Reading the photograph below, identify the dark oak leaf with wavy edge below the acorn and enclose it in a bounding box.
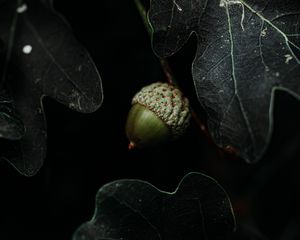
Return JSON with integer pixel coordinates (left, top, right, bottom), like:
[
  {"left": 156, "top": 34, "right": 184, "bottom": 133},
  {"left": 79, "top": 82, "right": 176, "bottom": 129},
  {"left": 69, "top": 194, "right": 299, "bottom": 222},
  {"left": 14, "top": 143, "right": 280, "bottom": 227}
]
[{"left": 73, "top": 173, "right": 235, "bottom": 240}]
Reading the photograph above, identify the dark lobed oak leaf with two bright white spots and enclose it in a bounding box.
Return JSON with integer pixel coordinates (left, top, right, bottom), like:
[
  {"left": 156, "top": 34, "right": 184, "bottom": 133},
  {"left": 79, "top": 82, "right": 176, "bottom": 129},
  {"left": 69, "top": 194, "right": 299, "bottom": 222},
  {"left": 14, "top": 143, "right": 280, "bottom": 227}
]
[{"left": 0, "top": 0, "right": 102, "bottom": 176}]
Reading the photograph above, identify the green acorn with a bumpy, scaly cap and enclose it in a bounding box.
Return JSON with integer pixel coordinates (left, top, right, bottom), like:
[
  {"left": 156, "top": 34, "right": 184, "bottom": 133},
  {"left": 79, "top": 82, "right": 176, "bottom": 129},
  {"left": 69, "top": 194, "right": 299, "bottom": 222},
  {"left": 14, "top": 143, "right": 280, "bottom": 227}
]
[{"left": 126, "top": 82, "right": 191, "bottom": 149}]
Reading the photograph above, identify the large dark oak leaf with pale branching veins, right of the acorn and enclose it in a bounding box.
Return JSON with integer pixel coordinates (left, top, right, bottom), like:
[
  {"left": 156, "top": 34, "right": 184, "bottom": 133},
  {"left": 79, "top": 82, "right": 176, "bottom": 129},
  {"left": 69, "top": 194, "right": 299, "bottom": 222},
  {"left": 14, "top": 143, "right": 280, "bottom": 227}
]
[{"left": 149, "top": 0, "right": 300, "bottom": 162}]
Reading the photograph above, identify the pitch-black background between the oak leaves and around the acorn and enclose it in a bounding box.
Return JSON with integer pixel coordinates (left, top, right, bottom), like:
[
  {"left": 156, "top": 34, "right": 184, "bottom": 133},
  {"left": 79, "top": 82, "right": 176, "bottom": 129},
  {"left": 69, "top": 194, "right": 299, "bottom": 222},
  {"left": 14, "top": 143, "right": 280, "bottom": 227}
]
[{"left": 0, "top": 0, "right": 300, "bottom": 240}]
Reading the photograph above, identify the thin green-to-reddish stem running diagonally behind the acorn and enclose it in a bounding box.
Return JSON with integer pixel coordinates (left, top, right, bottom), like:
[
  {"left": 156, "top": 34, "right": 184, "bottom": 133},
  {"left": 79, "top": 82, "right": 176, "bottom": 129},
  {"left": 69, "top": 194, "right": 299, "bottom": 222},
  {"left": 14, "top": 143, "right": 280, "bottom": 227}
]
[{"left": 134, "top": 0, "right": 213, "bottom": 143}]
